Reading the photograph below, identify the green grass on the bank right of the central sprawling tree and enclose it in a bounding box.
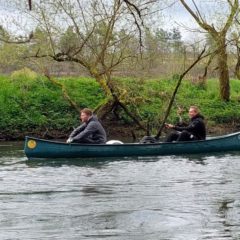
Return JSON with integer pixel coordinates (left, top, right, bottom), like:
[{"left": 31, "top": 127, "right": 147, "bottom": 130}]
[{"left": 111, "top": 76, "right": 240, "bottom": 131}]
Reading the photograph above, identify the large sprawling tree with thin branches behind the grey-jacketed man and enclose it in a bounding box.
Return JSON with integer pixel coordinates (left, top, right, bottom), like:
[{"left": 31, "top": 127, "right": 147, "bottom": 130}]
[{"left": 17, "top": 0, "right": 160, "bottom": 131}]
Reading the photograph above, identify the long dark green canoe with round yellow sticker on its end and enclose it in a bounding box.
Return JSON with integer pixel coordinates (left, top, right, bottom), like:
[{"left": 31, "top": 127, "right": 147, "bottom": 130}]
[{"left": 24, "top": 132, "right": 240, "bottom": 159}]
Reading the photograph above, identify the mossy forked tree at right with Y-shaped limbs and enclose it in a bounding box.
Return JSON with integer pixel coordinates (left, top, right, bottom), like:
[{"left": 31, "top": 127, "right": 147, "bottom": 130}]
[{"left": 180, "top": 0, "right": 239, "bottom": 101}]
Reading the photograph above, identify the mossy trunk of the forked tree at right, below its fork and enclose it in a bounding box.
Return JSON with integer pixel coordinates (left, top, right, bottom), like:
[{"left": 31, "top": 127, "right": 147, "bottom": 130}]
[{"left": 217, "top": 38, "right": 230, "bottom": 101}]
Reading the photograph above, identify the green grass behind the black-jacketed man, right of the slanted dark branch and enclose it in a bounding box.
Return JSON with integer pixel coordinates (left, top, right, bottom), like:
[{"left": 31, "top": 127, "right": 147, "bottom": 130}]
[{"left": 168, "top": 79, "right": 240, "bottom": 125}]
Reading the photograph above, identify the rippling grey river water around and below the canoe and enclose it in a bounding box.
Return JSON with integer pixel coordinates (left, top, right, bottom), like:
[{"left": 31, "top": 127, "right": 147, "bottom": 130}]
[{"left": 0, "top": 143, "right": 240, "bottom": 240}]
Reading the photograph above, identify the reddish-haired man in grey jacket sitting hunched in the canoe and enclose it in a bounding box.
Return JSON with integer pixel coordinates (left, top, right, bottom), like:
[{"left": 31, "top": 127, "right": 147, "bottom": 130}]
[{"left": 67, "top": 108, "right": 107, "bottom": 144}]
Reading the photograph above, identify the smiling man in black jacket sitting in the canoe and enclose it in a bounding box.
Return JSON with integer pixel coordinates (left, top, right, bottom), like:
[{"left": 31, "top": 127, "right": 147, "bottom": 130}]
[{"left": 166, "top": 106, "right": 206, "bottom": 142}]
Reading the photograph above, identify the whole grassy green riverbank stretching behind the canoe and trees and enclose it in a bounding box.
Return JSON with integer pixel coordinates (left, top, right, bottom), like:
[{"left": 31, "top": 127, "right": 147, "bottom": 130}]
[{"left": 0, "top": 72, "right": 240, "bottom": 139}]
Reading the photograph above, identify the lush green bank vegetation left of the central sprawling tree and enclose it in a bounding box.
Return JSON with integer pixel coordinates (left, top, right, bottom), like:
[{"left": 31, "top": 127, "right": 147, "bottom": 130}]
[{"left": 0, "top": 74, "right": 106, "bottom": 133}]
